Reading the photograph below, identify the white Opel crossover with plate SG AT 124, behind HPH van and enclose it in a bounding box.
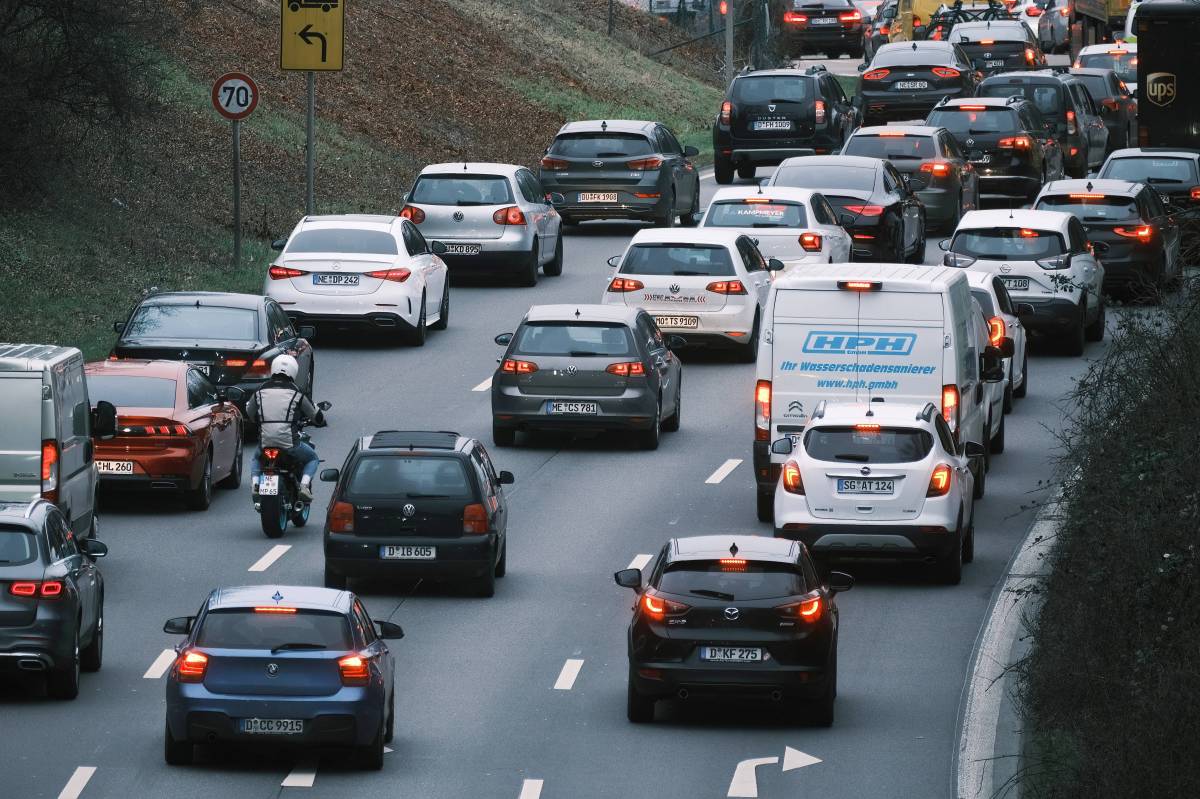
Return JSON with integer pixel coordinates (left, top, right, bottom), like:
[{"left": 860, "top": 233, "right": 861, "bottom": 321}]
[{"left": 772, "top": 402, "right": 980, "bottom": 584}]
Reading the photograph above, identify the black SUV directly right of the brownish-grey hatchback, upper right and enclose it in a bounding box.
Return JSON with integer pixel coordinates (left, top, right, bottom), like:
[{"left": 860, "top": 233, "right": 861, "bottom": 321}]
[{"left": 925, "top": 97, "right": 1062, "bottom": 200}]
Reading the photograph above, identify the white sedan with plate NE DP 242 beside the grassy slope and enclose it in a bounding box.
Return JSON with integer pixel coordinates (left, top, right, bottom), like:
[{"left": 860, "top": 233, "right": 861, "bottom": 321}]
[{"left": 263, "top": 214, "right": 450, "bottom": 347}]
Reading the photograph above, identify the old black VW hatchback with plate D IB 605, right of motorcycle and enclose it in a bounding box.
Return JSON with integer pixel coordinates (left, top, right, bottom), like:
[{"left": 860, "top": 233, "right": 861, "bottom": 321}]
[{"left": 320, "top": 431, "right": 514, "bottom": 596}]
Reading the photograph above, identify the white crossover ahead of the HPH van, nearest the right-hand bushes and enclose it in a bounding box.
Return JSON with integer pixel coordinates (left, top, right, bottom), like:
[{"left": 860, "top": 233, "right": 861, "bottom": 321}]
[{"left": 941, "top": 210, "right": 1104, "bottom": 355}]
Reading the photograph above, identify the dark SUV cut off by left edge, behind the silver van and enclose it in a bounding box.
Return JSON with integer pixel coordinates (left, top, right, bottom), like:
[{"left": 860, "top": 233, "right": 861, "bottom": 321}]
[{"left": 0, "top": 499, "right": 108, "bottom": 699}]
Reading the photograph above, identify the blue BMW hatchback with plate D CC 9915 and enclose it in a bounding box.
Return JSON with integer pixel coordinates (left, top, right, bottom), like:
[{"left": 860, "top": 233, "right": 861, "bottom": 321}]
[{"left": 163, "top": 585, "right": 404, "bottom": 769}]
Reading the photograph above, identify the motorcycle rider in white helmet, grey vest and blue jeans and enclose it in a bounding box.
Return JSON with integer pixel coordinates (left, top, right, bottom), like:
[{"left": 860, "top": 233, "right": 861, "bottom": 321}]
[{"left": 246, "top": 355, "right": 325, "bottom": 501}]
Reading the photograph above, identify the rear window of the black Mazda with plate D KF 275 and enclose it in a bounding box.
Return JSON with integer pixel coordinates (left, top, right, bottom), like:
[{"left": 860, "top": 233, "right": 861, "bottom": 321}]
[{"left": 656, "top": 558, "right": 808, "bottom": 602}]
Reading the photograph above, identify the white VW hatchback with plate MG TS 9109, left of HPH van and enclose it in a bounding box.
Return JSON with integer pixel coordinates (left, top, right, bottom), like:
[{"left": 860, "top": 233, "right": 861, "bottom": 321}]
[{"left": 600, "top": 228, "right": 784, "bottom": 361}]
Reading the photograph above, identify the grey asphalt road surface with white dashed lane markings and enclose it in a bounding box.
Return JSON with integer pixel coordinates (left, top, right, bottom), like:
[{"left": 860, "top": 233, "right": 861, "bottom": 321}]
[{"left": 0, "top": 169, "right": 1102, "bottom": 799}]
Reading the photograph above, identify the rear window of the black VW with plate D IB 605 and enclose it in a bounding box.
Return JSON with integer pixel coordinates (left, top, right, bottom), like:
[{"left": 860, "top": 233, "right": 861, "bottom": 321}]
[{"left": 346, "top": 455, "right": 475, "bottom": 499}]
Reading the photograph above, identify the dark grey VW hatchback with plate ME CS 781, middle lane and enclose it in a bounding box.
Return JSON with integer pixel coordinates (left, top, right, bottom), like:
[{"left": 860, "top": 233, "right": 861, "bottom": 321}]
[{"left": 492, "top": 305, "right": 683, "bottom": 450}]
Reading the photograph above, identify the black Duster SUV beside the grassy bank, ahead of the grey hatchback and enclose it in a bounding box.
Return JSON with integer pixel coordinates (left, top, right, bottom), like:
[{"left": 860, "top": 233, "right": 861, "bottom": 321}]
[{"left": 713, "top": 66, "right": 858, "bottom": 184}]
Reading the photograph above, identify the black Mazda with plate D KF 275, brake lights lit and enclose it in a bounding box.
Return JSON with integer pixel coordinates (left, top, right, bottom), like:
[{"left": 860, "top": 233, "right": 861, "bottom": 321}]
[{"left": 614, "top": 535, "right": 854, "bottom": 726}]
